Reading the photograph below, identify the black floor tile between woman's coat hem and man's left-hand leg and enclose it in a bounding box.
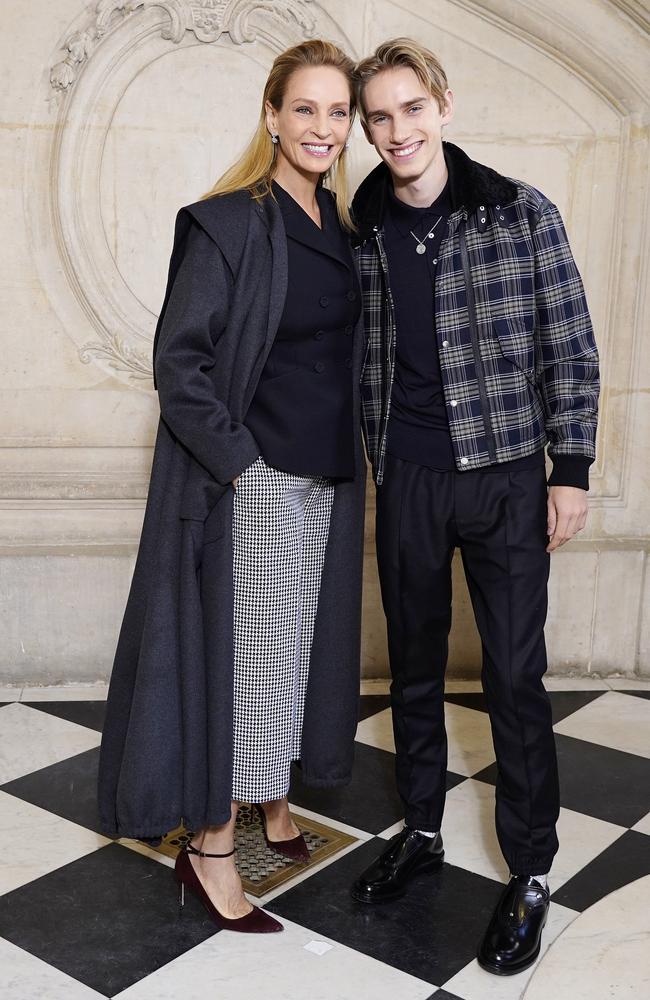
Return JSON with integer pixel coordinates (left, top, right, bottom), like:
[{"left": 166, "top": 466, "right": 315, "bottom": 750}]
[{"left": 289, "top": 743, "right": 465, "bottom": 833}]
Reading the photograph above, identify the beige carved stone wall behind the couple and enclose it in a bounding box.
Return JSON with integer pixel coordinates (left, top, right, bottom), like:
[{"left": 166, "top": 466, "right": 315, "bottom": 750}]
[{"left": 0, "top": 0, "right": 650, "bottom": 684}]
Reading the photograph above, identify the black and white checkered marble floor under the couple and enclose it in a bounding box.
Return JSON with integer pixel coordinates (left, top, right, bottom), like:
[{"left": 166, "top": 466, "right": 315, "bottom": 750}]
[{"left": 0, "top": 680, "right": 650, "bottom": 1000}]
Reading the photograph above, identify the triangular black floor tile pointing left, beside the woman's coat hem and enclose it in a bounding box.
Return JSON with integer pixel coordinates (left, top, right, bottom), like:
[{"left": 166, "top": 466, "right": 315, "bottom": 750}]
[{"left": 2, "top": 747, "right": 103, "bottom": 833}]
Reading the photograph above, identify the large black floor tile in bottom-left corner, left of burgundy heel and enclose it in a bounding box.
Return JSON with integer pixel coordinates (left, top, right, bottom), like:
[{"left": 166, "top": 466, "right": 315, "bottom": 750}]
[{"left": 0, "top": 844, "right": 215, "bottom": 997}]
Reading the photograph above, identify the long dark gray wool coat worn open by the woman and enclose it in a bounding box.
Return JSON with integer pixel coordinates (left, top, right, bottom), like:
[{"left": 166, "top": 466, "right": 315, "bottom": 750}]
[{"left": 98, "top": 186, "right": 365, "bottom": 839}]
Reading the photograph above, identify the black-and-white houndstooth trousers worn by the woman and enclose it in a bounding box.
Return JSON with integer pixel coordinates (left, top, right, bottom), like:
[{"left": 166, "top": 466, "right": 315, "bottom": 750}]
[{"left": 232, "top": 457, "right": 334, "bottom": 802}]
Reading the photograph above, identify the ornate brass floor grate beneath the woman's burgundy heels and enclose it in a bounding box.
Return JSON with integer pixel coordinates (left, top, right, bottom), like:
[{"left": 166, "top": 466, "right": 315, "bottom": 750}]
[{"left": 146, "top": 803, "right": 356, "bottom": 897}]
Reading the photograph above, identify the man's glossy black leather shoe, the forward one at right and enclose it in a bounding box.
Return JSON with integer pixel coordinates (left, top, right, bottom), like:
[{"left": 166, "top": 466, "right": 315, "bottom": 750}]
[{"left": 477, "top": 875, "right": 550, "bottom": 976}]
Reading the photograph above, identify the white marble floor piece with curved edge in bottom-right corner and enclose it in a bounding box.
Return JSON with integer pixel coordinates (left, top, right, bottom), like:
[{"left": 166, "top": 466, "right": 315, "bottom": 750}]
[{"left": 524, "top": 875, "right": 650, "bottom": 1000}]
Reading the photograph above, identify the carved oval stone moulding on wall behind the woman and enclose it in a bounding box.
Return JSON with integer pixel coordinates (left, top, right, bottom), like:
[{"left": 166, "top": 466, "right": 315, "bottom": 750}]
[{"left": 27, "top": 0, "right": 352, "bottom": 388}]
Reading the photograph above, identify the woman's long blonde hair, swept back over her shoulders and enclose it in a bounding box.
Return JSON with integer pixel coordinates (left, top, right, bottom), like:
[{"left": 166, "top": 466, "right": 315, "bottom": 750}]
[{"left": 203, "top": 38, "right": 356, "bottom": 230}]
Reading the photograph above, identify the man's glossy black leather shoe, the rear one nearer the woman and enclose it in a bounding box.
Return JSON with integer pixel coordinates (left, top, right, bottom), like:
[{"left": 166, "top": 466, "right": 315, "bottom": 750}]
[{"left": 351, "top": 828, "right": 445, "bottom": 903}]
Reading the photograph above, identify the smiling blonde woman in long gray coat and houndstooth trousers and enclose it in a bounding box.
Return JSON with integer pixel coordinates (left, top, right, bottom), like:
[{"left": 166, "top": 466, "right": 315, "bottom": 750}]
[{"left": 99, "top": 41, "right": 365, "bottom": 932}]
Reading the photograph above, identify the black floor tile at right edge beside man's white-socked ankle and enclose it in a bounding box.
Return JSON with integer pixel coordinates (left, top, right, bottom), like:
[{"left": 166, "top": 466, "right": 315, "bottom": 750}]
[{"left": 550, "top": 830, "right": 650, "bottom": 910}]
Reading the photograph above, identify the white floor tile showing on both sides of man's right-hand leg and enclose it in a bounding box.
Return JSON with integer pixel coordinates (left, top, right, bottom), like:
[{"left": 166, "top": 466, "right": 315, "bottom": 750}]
[{"left": 442, "top": 780, "right": 625, "bottom": 892}]
